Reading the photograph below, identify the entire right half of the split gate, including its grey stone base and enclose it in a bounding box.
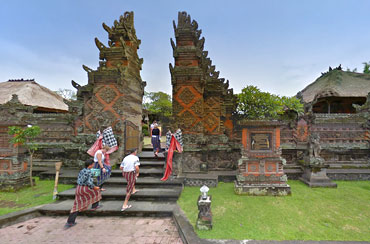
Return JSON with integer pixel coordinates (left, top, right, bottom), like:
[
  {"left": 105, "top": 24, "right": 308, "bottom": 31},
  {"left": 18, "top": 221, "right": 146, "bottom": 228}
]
[{"left": 170, "top": 12, "right": 237, "bottom": 174}]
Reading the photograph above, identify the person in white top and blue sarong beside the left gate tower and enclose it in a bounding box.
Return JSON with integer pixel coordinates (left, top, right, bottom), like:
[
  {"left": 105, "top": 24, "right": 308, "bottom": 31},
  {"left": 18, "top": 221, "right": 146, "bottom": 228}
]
[{"left": 94, "top": 146, "right": 112, "bottom": 191}]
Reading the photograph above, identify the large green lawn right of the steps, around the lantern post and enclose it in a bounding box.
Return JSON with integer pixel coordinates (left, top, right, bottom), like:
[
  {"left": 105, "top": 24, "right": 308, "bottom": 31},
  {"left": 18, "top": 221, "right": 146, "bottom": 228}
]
[{"left": 178, "top": 181, "right": 370, "bottom": 241}]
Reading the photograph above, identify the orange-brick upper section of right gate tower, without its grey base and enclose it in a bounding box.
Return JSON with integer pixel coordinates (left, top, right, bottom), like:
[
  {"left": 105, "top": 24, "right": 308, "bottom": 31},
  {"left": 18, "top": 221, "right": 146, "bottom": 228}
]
[{"left": 170, "top": 12, "right": 234, "bottom": 135}]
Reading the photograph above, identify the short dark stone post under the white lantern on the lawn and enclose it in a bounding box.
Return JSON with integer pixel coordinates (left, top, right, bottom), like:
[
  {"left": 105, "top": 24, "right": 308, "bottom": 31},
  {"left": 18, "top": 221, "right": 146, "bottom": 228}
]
[{"left": 196, "top": 196, "right": 212, "bottom": 230}]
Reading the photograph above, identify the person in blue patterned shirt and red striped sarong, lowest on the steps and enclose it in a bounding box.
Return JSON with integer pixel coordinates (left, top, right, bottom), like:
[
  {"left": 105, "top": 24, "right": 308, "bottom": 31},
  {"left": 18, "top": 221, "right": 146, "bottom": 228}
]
[{"left": 64, "top": 159, "right": 102, "bottom": 229}]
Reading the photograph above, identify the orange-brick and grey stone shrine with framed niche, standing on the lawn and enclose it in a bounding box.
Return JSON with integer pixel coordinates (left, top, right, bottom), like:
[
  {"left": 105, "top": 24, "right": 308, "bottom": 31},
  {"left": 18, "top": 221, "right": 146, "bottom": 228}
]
[{"left": 235, "top": 120, "right": 291, "bottom": 196}]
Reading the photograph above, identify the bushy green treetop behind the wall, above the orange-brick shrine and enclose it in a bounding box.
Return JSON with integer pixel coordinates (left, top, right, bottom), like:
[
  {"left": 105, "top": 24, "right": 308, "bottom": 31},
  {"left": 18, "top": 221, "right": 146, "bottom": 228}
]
[{"left": 236, "top": 86, "right": 303, "bottom": 120}]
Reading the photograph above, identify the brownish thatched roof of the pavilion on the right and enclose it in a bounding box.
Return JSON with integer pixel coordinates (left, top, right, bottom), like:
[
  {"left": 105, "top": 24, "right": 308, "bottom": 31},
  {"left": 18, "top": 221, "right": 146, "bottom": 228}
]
[{"left": 297, "top": 69, "right": 370, "bottom": 103}]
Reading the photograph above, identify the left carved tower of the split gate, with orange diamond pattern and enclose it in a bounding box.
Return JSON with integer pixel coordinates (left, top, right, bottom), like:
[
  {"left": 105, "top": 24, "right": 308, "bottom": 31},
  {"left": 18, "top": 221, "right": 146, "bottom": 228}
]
[{"left": 72, "top": 12, "right": 145, "bottom": 156}]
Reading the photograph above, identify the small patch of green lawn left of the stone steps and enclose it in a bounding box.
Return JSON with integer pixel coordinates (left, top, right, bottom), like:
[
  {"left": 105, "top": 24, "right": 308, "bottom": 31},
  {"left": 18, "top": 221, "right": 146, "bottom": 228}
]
[{"left": 0, "top": 177, "right": 74, "bottom": 215}]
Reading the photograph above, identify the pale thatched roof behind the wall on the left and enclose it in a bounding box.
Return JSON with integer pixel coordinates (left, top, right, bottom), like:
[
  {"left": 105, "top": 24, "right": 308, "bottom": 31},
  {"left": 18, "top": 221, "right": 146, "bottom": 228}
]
[{"left": 0, "top": 79, "right": 68, "bottom": 112}]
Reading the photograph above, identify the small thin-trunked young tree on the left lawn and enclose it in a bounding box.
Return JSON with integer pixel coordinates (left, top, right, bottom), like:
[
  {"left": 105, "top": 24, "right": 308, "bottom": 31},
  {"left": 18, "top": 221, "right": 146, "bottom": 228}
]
[{"left": 8, "top": 125, "right": 41, "bottom": 187}]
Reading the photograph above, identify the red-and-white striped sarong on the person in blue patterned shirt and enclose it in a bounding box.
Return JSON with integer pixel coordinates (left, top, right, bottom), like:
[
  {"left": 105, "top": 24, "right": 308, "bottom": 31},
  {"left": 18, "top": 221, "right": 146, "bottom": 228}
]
[{"left": 71, "top": 185, "right": 101, "bottom": 213}]
